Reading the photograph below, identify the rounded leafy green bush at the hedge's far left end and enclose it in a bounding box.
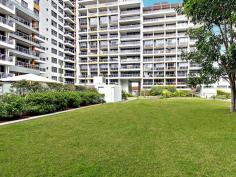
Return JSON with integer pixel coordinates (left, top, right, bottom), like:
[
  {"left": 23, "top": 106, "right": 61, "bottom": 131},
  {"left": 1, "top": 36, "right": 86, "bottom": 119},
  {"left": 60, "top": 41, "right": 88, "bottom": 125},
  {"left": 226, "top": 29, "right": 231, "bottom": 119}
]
[{"left": 0, "top": 94, "right": 25, "bottom": 119}]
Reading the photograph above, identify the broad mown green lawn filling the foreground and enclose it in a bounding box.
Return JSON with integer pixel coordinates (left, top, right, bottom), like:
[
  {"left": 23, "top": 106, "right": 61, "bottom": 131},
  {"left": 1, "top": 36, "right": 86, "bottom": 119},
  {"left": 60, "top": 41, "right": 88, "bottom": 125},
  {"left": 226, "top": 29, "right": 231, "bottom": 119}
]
[{"left": 0, "top": 99, "right": 236, "bottom": 177}]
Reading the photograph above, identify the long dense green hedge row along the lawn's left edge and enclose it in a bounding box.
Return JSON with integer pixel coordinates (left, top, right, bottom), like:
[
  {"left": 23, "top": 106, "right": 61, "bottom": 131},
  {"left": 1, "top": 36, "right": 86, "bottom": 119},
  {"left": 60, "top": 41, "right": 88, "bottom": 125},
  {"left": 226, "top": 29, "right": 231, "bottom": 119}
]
[{"left": 0, "top": 91, "right": 104, "bottom": 119}]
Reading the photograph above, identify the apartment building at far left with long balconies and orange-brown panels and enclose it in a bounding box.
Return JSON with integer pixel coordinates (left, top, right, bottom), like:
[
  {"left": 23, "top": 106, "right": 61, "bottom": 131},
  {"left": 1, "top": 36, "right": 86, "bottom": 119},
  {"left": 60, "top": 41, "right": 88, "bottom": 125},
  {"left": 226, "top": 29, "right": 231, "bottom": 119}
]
[{"left": 0, "top": 0, "right": 44, "bottom": 78}]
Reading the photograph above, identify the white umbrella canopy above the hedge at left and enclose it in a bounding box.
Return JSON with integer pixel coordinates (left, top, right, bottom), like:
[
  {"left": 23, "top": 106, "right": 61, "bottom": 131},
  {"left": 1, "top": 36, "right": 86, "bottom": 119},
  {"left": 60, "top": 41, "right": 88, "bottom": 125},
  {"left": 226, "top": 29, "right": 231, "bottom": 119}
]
[{"left": 0, "top": 74, "right": 58, "bottom": 83}]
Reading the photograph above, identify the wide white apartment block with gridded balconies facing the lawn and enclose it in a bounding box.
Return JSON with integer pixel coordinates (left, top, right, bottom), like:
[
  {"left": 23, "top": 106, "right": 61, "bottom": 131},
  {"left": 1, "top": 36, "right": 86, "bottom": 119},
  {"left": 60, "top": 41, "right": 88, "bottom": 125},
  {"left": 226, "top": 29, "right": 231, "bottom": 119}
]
[{"left": 76, "top": 0, "right": 200, "bottom": 93}]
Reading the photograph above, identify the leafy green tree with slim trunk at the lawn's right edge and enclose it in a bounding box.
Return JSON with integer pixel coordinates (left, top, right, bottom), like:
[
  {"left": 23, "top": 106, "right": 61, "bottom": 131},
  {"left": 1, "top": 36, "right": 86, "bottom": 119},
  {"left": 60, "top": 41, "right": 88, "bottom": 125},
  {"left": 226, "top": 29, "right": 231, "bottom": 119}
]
[{"left": 179, "top": 0, "right": 236, "bottom": 112}]
